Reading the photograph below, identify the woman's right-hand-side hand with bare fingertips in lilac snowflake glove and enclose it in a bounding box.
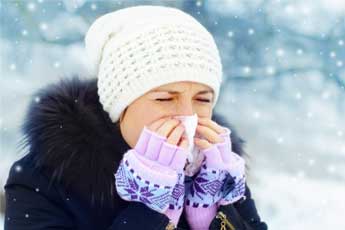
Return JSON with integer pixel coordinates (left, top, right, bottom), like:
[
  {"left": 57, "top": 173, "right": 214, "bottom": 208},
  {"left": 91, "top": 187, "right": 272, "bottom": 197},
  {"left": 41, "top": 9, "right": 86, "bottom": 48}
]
[{"left": 186, "top": 118, "right": 245, "bottom": 207}]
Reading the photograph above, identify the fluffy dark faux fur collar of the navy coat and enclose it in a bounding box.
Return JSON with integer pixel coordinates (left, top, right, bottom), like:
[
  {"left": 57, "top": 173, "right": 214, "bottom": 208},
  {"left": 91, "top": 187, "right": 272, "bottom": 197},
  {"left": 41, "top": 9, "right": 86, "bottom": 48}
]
[{"left": 18, "top": 76, "right": 244, "bottom": 209}]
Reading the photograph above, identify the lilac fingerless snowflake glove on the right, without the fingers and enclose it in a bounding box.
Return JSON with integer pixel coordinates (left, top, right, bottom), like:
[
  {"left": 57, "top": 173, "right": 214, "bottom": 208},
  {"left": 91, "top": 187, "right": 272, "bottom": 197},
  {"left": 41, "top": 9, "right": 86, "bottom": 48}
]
[{"left": 185, "top": 128, "right": 245, "bottom": 229}]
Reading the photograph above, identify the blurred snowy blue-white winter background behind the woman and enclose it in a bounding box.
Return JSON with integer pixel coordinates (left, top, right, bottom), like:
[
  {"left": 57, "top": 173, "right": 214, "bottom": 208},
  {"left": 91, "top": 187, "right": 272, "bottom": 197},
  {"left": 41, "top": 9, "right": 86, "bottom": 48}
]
[{"left": 0, "top": 0, "right": 345, "bottom": 230}]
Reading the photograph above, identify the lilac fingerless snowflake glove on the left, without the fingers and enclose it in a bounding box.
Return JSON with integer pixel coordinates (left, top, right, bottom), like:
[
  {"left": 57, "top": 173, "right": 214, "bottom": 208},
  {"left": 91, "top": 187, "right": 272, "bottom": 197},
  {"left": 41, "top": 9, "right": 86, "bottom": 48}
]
[{"left": 115, "top": 127, "right": 187, "bottom": 224}]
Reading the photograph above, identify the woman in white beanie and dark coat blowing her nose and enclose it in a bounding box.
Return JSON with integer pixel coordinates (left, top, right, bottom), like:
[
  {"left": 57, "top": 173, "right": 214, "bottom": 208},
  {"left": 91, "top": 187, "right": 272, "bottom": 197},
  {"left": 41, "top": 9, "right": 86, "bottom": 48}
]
[{"left": 4, "top": 6, "right": 267, "bottom": 230}]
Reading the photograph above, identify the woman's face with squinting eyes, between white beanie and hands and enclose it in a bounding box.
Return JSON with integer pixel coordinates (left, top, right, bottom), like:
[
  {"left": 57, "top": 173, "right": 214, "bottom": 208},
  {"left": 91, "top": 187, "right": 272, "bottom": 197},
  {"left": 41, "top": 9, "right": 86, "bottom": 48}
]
[{"left": 120, "top": 81, "right": 214, "bottom": 148}]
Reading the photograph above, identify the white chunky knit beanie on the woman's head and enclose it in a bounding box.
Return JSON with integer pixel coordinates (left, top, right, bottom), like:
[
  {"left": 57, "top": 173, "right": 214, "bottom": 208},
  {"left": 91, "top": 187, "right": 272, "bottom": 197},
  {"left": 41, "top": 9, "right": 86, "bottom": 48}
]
[{"left": 85, "top": 5, "right": 222, "bottom": 122}]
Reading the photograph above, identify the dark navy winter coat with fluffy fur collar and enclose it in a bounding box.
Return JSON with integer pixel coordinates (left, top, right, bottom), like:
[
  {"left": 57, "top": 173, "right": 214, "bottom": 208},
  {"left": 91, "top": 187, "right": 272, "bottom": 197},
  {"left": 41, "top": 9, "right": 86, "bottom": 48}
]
[{"left": 4, "top": 77, "right": 267, "bottom": 230}]
